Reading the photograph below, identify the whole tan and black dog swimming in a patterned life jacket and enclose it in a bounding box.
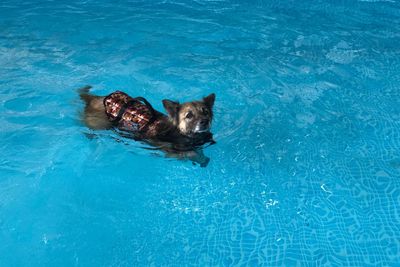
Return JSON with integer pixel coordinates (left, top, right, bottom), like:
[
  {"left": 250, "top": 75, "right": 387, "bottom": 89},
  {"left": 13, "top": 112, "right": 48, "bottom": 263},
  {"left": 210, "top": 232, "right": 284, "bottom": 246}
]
[{"left": 78, "top": 86, "right": 215, "bottom": 167}]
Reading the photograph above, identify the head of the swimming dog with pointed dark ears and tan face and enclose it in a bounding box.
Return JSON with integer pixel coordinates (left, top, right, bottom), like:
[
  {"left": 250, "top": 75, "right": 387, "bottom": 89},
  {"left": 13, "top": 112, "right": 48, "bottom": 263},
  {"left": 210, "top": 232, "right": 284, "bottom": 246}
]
[{"left": 163, "top": 94, "right": 215, "bottom": 136}]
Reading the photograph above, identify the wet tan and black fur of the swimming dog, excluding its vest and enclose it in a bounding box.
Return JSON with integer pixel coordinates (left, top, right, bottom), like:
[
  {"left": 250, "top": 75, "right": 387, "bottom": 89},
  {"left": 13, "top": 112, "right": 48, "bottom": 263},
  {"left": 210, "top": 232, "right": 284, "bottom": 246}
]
[{"left": 78, "top": 86, "right": 215, "bottom": 167}]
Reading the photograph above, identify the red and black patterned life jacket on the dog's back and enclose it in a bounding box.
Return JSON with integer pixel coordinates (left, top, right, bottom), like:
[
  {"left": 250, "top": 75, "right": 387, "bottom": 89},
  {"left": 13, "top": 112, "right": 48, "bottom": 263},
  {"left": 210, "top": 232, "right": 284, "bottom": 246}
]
[{"left": 103, "top": 91, "right": 155, "bottom": 132}]
